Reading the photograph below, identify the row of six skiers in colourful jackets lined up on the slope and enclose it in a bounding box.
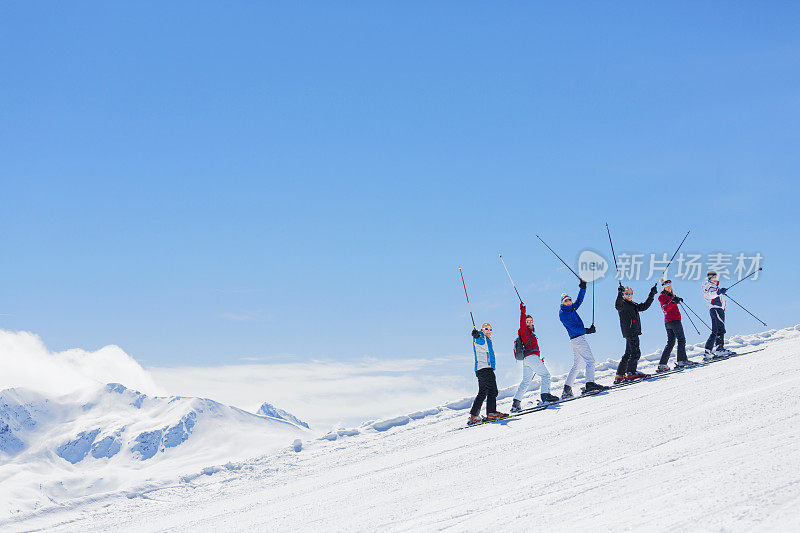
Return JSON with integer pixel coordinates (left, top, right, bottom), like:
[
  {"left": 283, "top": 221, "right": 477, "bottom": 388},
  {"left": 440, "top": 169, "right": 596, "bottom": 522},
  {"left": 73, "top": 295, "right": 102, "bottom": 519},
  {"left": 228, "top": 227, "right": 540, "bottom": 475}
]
[{"left": 467, "top": 270, "right": 733, "bottom": 425}]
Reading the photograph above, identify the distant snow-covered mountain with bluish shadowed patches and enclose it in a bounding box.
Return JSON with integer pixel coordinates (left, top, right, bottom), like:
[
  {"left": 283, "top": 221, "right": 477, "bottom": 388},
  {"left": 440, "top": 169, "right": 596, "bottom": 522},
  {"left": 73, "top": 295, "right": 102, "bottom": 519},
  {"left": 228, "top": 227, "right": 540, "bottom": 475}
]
[{"left": 0, "top": 383, "right": 308, "bottom": 516}]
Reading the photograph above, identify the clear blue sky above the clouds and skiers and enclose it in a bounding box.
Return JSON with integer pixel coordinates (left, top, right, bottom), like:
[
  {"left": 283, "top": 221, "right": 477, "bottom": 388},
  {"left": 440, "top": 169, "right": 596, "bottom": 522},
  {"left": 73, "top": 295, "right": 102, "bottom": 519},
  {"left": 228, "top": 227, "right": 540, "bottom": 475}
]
[{"left": 0, "top": 2, "right": 800, "bottom": 400}]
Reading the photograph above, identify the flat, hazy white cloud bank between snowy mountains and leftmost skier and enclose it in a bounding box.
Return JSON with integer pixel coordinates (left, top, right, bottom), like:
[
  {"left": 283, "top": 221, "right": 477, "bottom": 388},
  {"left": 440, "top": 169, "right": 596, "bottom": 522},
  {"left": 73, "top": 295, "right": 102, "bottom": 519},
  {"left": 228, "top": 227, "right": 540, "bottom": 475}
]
[{"left": 149, "top": 357, "right": 476, "bottom": 430}]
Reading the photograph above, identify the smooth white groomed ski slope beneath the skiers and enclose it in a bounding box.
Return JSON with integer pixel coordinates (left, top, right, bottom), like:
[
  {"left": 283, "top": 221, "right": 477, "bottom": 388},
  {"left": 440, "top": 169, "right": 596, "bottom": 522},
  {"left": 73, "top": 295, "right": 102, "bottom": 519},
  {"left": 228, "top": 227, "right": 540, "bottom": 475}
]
[{"left": 0, "top": 326, "right": 800, "bottom": 532}]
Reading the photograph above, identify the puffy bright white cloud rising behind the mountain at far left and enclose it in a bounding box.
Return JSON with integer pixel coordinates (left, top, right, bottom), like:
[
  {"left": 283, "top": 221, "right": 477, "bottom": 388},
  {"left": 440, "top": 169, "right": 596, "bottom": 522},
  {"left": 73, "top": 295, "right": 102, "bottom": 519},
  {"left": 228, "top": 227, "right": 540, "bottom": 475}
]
[{"left": 0, "top": 330, "right": 163, "bottom": 395}]
